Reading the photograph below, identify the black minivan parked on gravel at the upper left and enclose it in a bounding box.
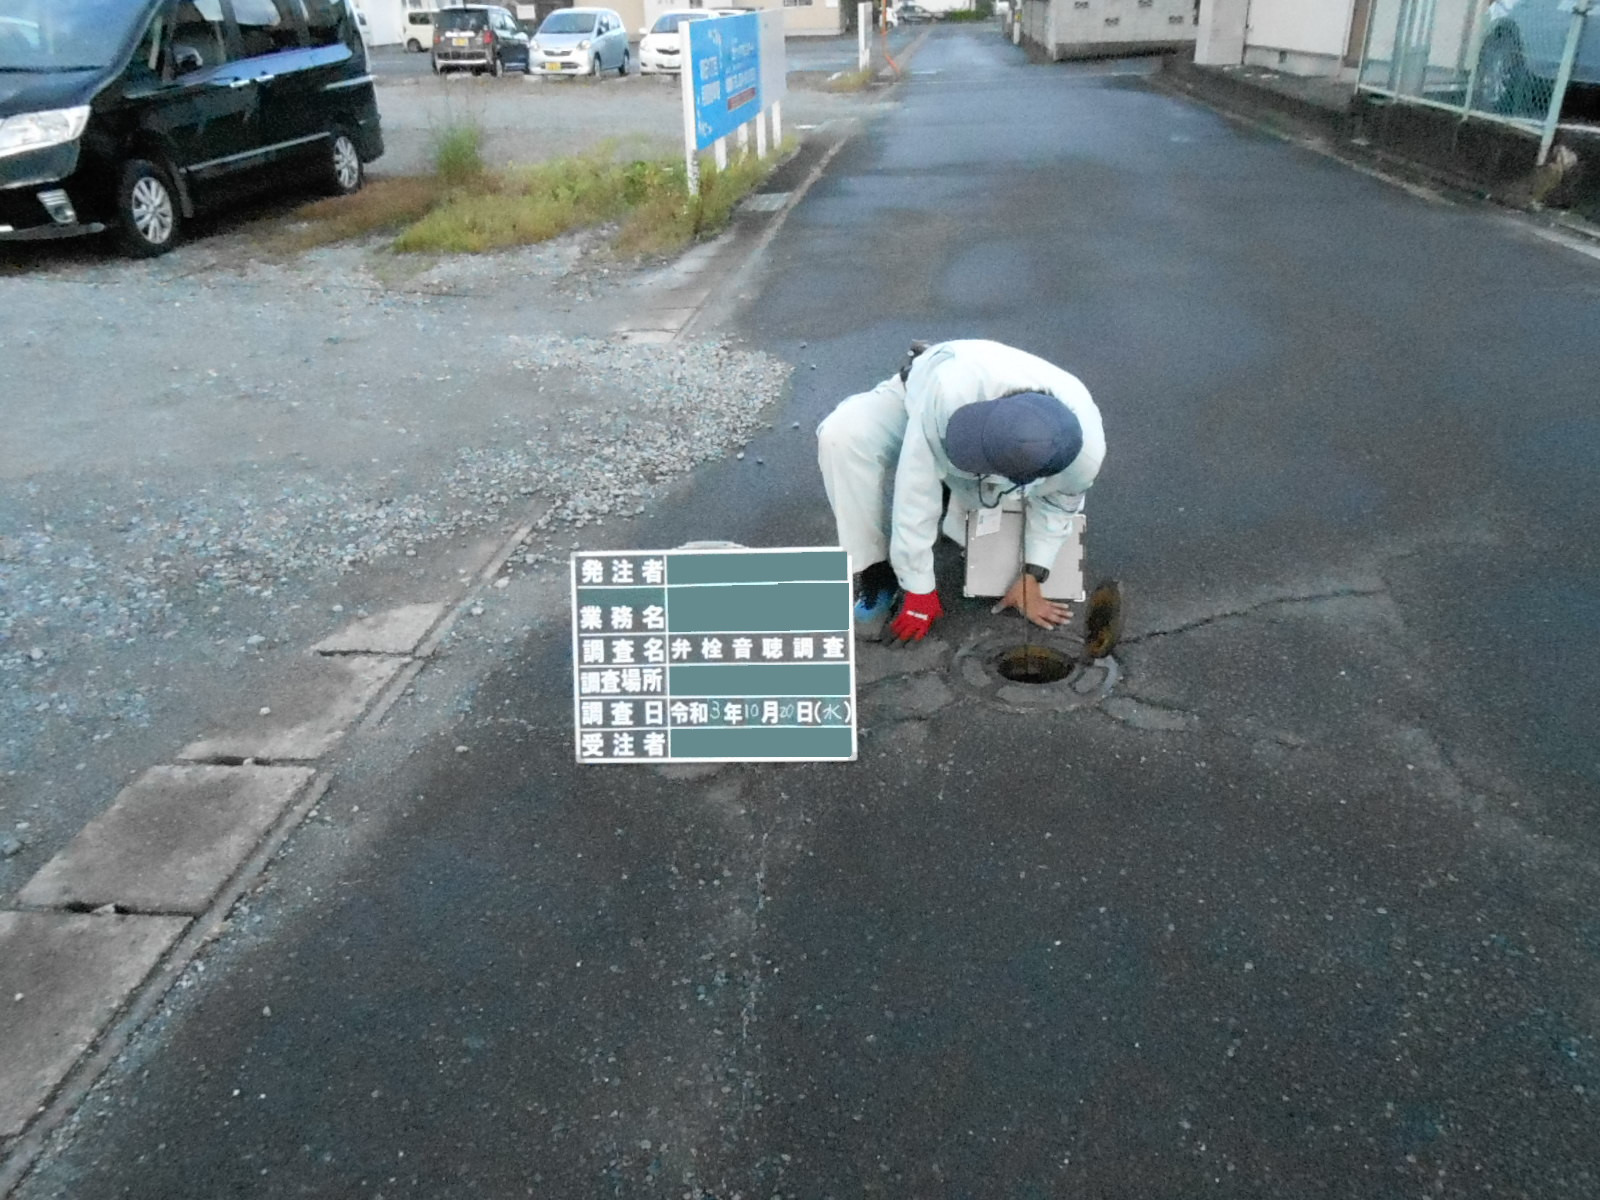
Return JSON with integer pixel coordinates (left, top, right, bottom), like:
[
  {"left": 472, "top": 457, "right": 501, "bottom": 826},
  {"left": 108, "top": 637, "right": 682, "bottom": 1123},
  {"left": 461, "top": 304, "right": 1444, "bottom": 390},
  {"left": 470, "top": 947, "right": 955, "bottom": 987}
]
[{"left": 0, "top": 0, "right": 384, "bottom": 256}]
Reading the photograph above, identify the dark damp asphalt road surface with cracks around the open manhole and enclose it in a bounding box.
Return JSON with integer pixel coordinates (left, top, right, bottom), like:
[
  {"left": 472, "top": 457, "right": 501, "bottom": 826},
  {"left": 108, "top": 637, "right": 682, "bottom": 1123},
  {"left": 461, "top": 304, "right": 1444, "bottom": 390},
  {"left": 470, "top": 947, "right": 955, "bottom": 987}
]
[{"left": 21, "top": 29, "right": 1600, "bottom": 1200}]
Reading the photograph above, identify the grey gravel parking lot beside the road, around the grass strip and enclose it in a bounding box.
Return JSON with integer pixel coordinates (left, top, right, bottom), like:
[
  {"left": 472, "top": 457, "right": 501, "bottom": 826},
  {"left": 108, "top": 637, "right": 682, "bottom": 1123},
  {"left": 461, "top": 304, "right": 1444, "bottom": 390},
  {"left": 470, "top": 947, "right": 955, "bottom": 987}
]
[{"left": 0, "top": 58, "right": 877, "bottom": 894}]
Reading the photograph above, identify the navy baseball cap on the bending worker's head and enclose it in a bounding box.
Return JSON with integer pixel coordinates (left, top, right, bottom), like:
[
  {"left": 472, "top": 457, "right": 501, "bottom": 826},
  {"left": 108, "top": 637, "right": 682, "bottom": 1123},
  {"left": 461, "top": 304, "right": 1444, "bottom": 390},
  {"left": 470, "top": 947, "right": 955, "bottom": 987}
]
[{"left": 944, "top": 392, "right": 1083, "bottom": 483}]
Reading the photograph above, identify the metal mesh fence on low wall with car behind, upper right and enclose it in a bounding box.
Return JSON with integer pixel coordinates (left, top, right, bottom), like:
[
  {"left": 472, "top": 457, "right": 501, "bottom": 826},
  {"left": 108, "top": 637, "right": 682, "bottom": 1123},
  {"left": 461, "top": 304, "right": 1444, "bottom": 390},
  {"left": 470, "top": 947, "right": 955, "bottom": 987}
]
[{"left": 1357, "top": 0, "right": 1600, "bottom": 163}]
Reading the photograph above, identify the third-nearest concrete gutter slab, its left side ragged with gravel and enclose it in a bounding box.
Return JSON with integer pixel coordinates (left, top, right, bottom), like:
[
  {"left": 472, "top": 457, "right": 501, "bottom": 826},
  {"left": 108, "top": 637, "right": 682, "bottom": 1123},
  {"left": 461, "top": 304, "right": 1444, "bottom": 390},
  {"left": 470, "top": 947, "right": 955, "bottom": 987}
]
[{"left": 178, "top": 654, "right": 402, "bottom": 762}]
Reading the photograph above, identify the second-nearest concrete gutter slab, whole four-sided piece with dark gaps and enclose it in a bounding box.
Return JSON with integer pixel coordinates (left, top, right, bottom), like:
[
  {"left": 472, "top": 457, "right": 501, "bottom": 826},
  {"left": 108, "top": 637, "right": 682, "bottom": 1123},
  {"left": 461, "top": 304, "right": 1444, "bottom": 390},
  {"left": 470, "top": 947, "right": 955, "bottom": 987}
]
[{"left": 18, "top": 766, "right": 315, "bottom": 914}]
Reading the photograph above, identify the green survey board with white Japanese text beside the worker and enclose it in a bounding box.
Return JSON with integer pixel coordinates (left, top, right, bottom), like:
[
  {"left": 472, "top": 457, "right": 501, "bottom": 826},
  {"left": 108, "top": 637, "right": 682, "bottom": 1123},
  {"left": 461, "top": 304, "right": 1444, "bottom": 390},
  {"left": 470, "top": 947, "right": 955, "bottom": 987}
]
[{"left": 573, "top": 549, "right": 856, "bottom": 763}]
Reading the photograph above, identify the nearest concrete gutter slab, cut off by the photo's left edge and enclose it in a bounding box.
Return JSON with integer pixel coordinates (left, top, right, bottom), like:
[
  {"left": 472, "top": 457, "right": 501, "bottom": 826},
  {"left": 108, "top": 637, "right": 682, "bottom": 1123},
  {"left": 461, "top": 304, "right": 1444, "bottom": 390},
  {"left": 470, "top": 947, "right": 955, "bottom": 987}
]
[{"left": 0, "top": 912, "right": 189, "bottom": 1138}]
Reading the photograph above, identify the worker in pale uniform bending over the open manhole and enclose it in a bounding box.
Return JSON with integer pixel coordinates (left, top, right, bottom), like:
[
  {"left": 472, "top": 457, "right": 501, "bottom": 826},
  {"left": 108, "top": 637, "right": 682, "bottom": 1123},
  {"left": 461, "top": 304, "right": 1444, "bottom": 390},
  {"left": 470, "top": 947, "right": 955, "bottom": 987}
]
[{"left": 816, "top": 341, "right": 1106, "bottom": 642}]
